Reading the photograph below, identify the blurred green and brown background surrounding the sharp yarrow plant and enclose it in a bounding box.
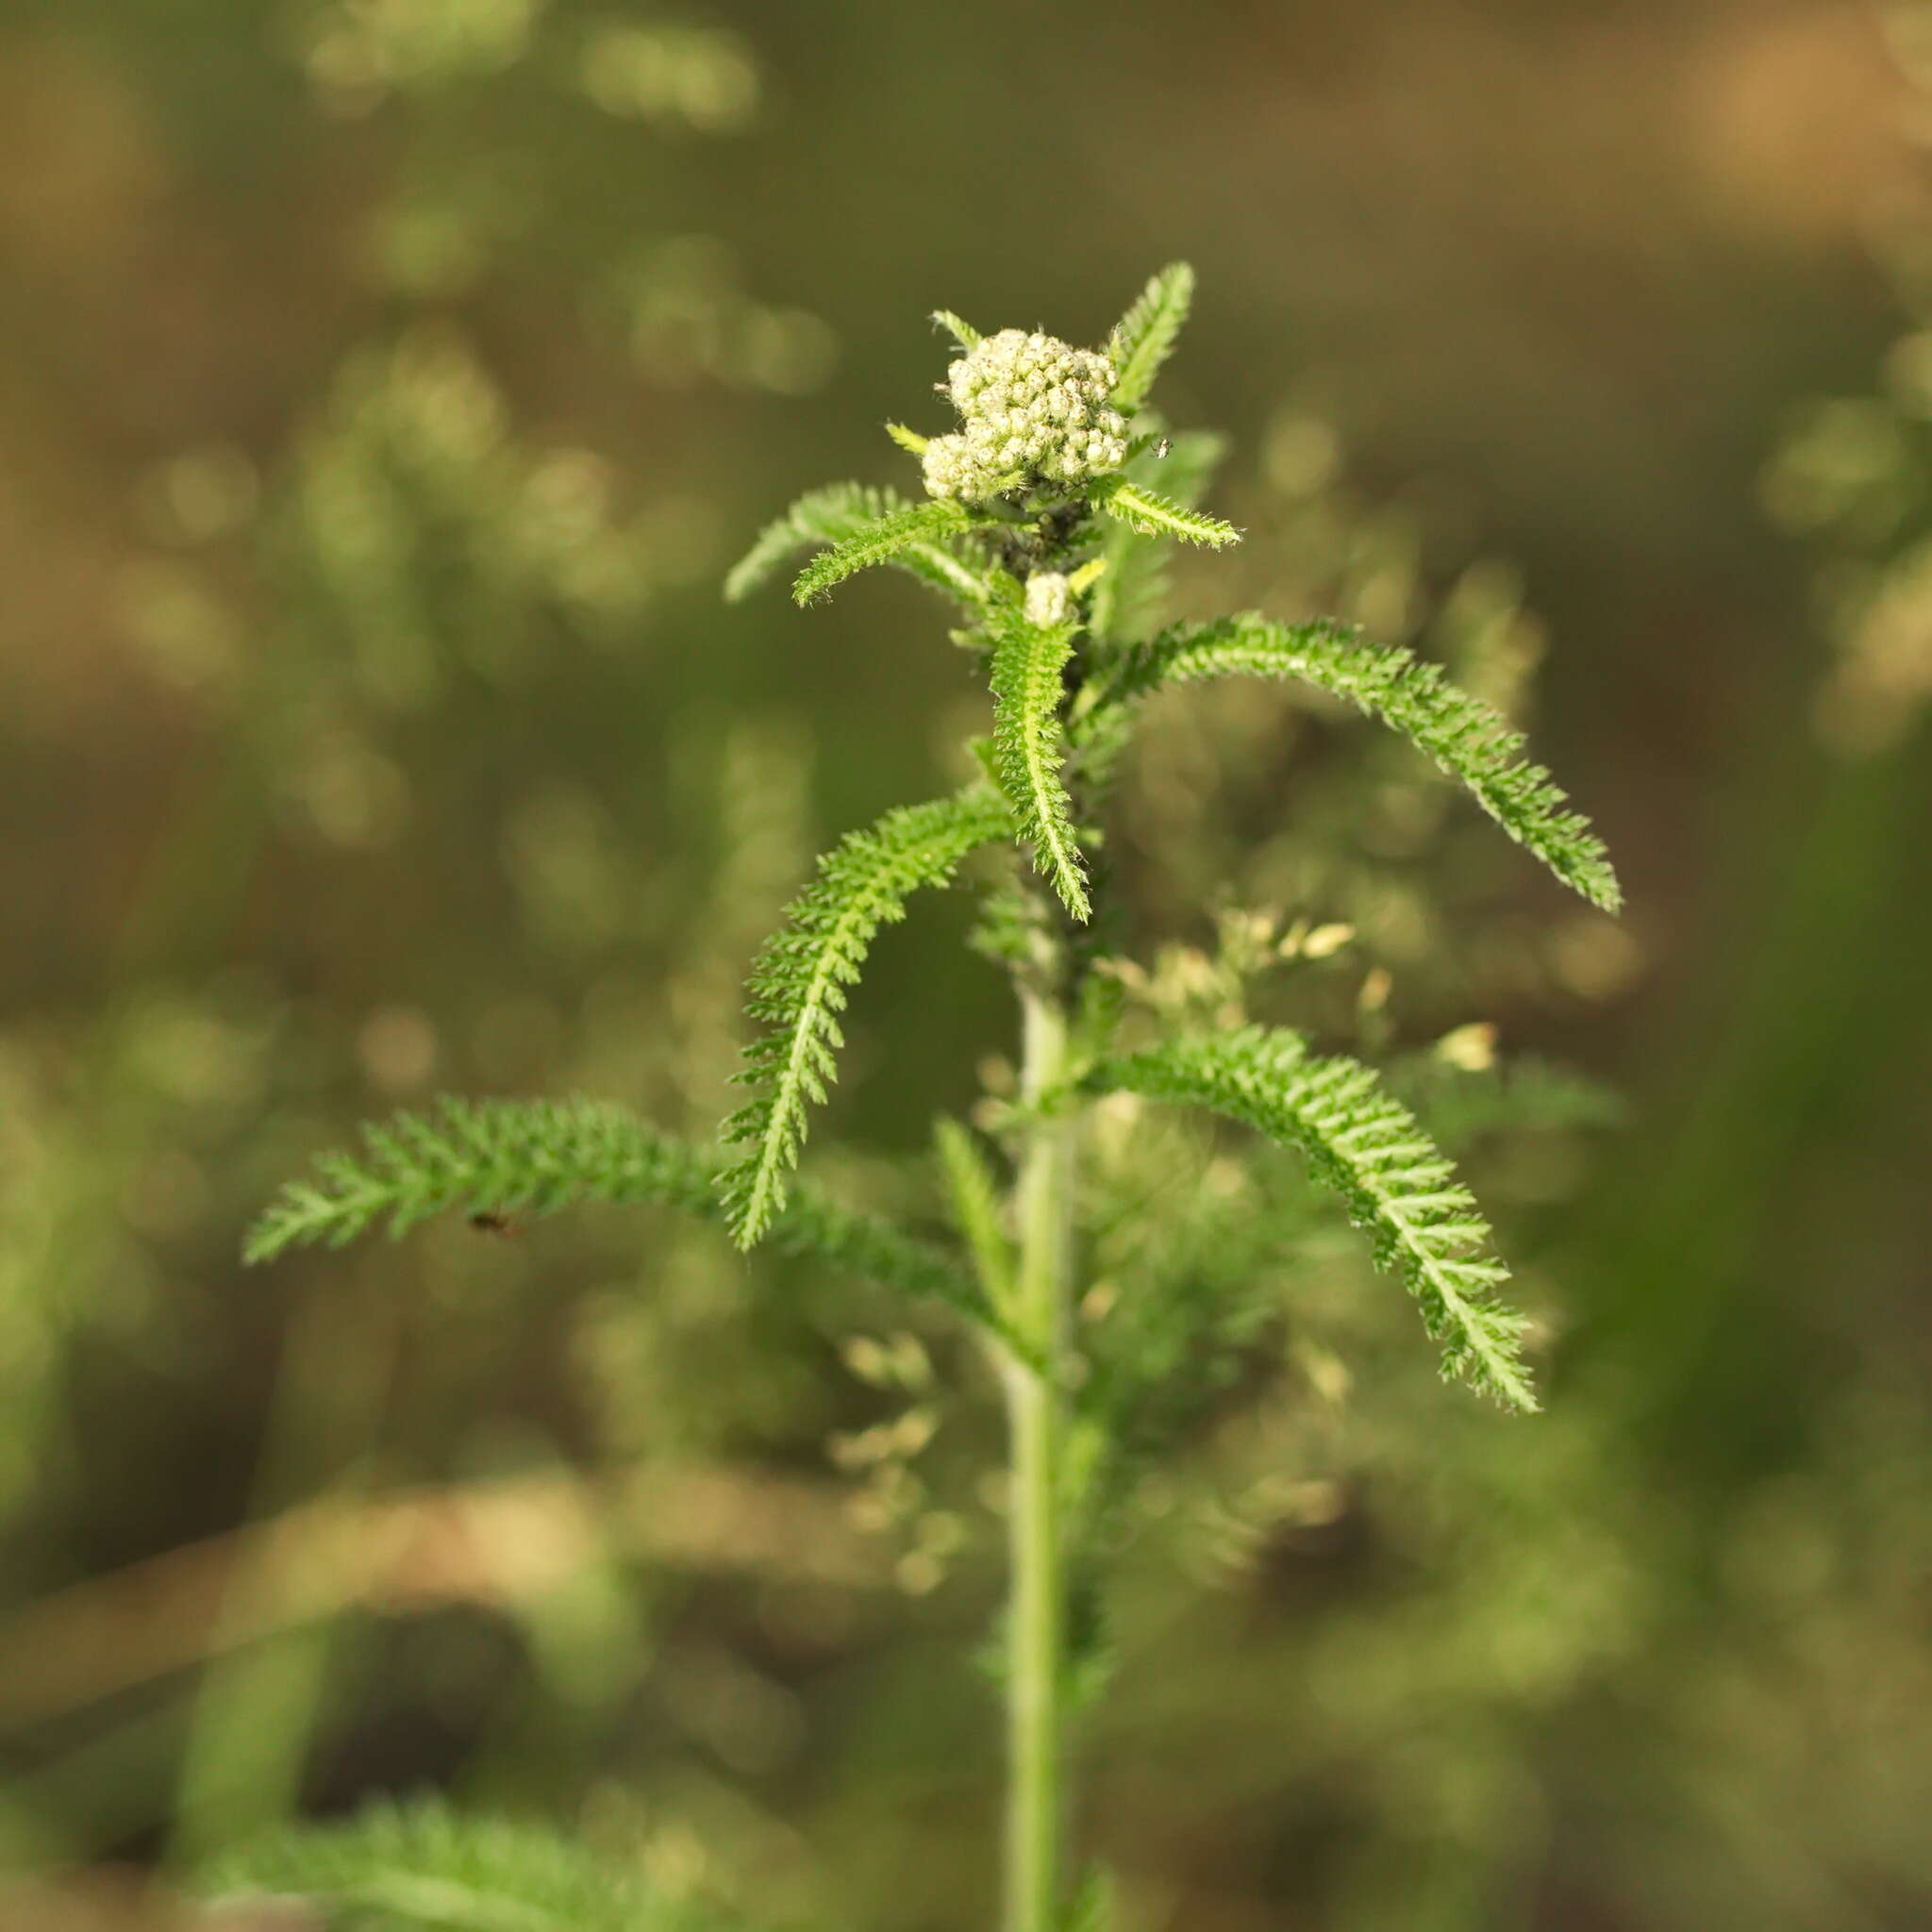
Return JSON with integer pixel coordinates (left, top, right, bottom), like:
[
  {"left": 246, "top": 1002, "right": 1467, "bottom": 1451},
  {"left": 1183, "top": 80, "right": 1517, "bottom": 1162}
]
[{"left": 0, "top": 0, "right": 1932, "bottom": 1932}]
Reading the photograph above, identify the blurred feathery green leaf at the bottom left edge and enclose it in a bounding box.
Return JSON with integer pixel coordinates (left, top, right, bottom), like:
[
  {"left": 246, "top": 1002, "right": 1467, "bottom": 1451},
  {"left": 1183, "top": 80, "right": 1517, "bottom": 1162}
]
[{"left": 199, "top": 1799, "right": 721, "bottom": 1932}]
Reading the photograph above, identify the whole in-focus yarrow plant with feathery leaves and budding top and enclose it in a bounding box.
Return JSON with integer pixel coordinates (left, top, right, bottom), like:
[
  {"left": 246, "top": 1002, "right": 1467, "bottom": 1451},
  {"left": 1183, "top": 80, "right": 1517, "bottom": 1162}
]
[{"left": 222, "top": 265, "right": 1619, "bottom": 1932}]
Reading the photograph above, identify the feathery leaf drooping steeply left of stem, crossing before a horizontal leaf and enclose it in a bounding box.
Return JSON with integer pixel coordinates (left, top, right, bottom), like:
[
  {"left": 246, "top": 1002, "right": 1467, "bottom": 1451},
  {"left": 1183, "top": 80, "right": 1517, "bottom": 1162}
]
[{"left": 721, "top": 787, "right": 1012, "bottom": 1248}]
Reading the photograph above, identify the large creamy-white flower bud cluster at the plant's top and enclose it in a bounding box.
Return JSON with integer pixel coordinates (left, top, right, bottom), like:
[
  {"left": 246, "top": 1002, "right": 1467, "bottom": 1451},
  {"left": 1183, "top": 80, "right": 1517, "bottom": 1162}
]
[{"left": 925, "top": 328, "right": 1126, "bottom": 502}]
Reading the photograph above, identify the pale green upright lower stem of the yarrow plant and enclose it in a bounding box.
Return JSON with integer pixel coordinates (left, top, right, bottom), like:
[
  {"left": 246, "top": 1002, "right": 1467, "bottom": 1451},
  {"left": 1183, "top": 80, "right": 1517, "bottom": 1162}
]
[{"left": 1005, "top": 990, "right": 1078, "bottom": 1932}]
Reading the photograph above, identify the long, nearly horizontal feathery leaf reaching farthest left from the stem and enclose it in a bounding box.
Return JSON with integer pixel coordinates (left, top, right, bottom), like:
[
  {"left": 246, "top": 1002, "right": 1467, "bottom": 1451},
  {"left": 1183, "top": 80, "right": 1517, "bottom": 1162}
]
[{"left": 243, "top": 1099, "right": 991, "bottom": 1324}]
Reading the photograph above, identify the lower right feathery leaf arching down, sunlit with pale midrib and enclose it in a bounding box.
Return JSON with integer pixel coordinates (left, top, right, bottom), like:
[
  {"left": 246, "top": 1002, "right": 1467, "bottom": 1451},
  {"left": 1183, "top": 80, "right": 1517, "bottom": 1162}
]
[{"left": 1093, "top": 1028, "right": 1536, "bottom": 1408}]
